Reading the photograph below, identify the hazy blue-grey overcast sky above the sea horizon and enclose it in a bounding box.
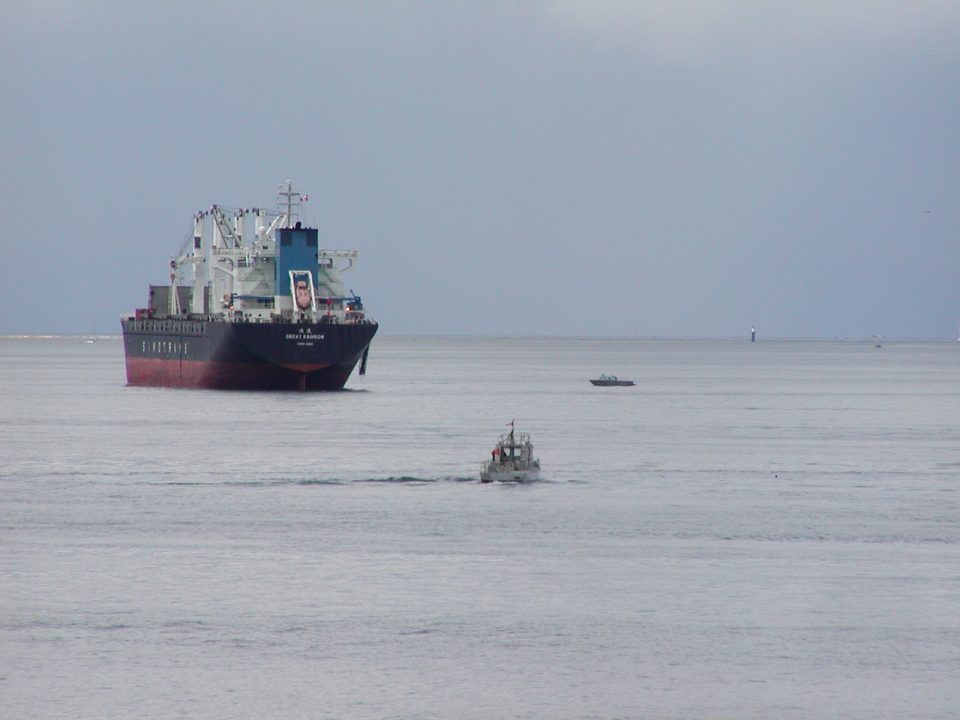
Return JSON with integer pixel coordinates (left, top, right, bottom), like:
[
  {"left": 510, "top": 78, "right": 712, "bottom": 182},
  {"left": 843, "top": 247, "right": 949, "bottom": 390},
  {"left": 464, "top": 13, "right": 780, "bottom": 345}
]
[{"left": 0, "top": 0, "right": 960, "bottom": 338}]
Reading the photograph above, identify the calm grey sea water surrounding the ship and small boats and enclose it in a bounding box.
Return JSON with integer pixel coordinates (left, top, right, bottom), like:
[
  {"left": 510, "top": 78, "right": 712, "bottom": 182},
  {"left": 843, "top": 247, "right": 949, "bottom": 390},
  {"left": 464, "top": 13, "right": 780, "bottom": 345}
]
[{"left": 0, "top": 337, "right": 960, "bottom": 720}]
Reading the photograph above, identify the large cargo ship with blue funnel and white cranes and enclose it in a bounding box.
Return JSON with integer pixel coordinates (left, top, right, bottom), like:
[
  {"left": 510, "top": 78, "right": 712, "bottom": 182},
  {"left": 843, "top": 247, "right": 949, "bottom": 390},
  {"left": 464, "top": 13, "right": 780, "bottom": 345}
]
[{"left": 121, "top": 182, "right": 378, "bottom": 391}]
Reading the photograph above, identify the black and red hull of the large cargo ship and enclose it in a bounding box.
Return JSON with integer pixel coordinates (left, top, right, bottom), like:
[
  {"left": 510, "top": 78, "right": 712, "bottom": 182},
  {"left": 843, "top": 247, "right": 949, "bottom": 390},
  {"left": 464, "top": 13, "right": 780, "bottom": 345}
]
[{"left": 122, "top": 318, "right": 378, "bottom": 390}]
